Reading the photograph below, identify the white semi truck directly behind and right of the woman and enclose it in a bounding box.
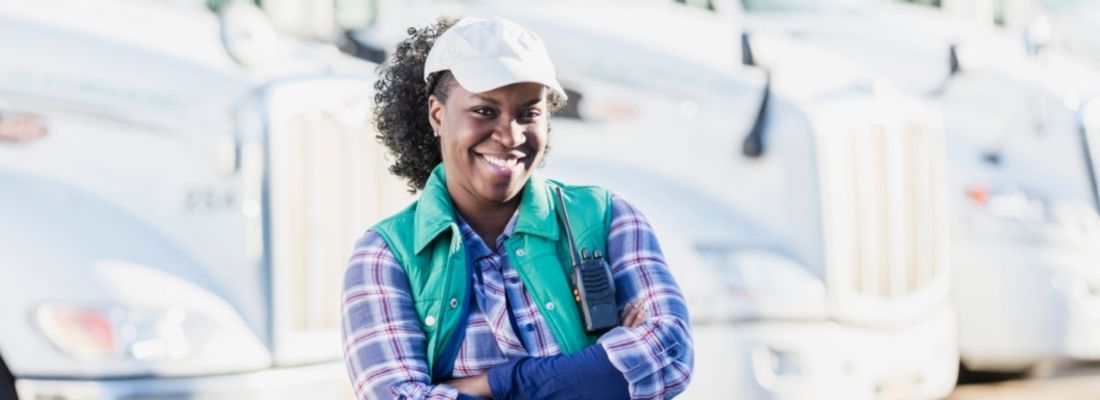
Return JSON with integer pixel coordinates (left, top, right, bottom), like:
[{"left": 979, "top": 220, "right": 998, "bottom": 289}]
[{"left": 321, "top": 1, "right": 958, "bottom": 399}]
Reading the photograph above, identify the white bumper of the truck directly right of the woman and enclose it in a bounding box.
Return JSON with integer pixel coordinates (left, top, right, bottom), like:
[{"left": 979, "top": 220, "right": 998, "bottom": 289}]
[{"left": 684, "top": 308, "right": 958, "bottom": 399}]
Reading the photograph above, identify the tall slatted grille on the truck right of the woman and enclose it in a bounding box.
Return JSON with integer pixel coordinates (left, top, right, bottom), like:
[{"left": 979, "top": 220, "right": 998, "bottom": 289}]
[{"left": 821, "top": 115, "right": 946, "bottom": 302}]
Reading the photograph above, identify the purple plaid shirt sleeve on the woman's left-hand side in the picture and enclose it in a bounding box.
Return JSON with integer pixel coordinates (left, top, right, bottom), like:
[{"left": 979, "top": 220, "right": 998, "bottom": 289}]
[{"left": 342, "top": 232, "right": 459, "bottom": 400}]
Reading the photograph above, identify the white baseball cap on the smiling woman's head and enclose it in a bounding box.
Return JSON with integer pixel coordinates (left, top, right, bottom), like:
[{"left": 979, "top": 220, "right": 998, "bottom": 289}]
[{"left": 424, "top": 16, "right": 565, "bottom": 98}]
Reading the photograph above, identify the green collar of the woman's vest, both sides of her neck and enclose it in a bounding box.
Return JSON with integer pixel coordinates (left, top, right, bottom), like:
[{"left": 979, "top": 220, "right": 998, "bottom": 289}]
[{"left": 414, "top": 164, "right": 558, "bottom": 253}]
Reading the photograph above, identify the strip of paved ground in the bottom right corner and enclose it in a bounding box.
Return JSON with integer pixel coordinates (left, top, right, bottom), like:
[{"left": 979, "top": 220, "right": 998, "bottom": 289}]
[{"left": 947, "top": 365, "right": 1100, "bottom": 400}]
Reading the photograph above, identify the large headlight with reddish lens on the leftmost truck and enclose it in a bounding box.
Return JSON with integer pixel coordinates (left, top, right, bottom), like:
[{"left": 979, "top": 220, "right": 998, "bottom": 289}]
[{"left": 28, "top": 259, "right": 272, "bottom": 376}]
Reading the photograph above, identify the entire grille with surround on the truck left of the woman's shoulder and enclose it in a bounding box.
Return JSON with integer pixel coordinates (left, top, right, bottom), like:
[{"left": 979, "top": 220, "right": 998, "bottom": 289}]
[{"left": 267, "top": 87, "right": 410, "bottom": 360}]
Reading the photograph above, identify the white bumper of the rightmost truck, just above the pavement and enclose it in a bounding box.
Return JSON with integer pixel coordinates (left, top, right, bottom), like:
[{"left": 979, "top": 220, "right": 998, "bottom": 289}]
[{"left": 953, "top": 232, "right": 1100, "bottom": 370}]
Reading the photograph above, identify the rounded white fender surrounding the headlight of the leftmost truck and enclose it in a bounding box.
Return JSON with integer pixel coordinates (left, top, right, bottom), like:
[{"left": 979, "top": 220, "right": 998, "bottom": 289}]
[{"left": 0, "top": 170, "right": 270, "bottom": 377}]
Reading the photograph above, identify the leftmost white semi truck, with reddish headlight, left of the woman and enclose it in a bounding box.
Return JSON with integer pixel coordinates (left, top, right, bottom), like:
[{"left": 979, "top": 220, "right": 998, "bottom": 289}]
[{"left": 0, "top": 0, "right": 407, "bottom": 400}]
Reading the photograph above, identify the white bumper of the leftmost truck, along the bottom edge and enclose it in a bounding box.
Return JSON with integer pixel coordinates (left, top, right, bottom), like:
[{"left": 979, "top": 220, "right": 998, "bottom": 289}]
[{"left": 15, "top": 363, "right": 352, "bottom": 400}]
